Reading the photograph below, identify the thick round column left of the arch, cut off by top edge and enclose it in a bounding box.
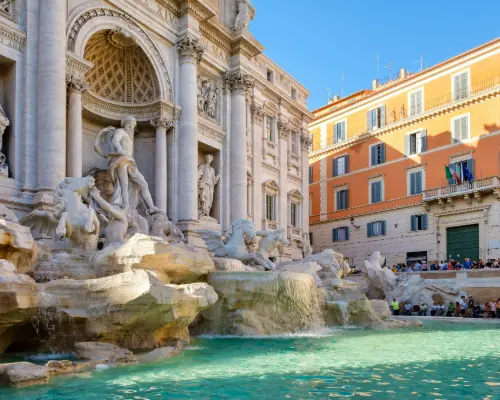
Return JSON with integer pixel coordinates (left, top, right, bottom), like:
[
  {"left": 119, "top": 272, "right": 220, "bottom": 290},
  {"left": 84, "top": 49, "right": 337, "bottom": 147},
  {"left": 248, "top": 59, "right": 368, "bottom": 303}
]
[{"left": 37, "top": 0, "right": 66, "bottom": 192}]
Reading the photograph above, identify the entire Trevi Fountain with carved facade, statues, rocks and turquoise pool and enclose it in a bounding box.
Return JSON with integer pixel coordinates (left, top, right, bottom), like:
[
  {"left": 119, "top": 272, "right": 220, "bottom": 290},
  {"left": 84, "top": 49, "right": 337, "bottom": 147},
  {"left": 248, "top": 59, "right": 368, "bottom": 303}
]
[{"left": 0, "top": 0, "right": 500, "bottom": 400}]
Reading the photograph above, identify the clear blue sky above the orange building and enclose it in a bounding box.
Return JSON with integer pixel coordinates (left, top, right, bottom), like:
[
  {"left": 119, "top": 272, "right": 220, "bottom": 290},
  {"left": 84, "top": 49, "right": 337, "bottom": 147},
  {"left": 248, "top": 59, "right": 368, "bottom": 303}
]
[{"left": 250, "top": 0, "right": 500, "bottom": 110}]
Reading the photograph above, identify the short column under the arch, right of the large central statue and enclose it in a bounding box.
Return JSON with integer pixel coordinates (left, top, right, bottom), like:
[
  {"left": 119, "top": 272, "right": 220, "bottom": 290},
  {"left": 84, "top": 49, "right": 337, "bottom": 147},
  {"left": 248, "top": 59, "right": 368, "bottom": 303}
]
[{"left": 151, "top": 117, "right": 174, "bottom": 213}]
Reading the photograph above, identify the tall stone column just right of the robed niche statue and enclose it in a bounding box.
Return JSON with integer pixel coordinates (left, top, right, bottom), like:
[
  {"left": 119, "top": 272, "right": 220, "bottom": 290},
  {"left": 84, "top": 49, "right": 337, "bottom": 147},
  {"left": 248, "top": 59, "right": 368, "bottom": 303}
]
[{"left": 226, "top": 72, "right": 251, "bottom": 222}]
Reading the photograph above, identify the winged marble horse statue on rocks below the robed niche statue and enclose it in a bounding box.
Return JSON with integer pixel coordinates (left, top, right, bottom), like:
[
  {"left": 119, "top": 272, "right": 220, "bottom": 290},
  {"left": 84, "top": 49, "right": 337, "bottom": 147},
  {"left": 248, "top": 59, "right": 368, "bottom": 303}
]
[{"left": 197, "top": 218, "right": 255, "bottom": 263}]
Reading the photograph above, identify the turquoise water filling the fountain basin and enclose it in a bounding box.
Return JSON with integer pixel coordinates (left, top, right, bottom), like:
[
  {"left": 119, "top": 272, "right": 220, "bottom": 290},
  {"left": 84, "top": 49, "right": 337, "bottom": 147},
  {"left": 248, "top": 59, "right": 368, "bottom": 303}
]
[{"left": 0, "top": 322, "right": 500, "bottom": 400}]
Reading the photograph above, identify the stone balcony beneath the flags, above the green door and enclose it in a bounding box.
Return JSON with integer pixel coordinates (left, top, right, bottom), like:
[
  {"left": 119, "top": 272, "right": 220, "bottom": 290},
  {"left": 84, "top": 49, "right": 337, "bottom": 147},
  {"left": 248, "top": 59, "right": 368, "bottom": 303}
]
[{"left": 423, "top": 176, "right": 500, "bottom": 204}]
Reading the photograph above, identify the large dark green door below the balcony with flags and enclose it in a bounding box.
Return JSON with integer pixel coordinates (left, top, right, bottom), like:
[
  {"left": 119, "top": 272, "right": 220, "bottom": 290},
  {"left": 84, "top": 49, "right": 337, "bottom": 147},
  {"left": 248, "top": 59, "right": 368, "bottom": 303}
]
[{"left": 446, "top": 224, "right": 479, "bottom": 263}]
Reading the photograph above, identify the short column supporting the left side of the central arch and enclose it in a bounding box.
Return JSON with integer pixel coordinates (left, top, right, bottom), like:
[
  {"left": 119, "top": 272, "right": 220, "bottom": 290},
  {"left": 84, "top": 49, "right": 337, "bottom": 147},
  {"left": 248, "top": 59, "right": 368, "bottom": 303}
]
[{"left": 66, "top": 76, "right": 88, "bottom": 178}]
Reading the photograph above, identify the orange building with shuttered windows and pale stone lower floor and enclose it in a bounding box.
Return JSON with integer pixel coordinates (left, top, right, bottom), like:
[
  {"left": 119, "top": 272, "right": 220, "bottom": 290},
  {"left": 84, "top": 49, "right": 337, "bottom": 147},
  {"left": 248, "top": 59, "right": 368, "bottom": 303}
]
[{"left": 309, "top": 39, "right": 500, "bottom": 266}]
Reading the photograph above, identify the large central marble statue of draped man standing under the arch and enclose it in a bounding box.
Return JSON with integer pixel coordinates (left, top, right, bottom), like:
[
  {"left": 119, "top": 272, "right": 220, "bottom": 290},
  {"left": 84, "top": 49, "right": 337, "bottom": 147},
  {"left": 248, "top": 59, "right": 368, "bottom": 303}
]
[{"left": 94, "top": 117, "right": 160, "bottom": 213}]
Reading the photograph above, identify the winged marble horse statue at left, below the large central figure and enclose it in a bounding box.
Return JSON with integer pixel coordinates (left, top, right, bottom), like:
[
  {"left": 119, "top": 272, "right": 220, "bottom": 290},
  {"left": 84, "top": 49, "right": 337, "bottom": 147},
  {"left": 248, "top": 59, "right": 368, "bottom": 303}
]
[{"left": 20, "top": 176, "right": 100, "bottom": 250}]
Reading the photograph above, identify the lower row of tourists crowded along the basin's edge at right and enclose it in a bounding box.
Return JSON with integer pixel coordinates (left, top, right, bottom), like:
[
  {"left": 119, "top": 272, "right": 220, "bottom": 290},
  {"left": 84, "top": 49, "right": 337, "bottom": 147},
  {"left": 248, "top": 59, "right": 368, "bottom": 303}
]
[{"left": 391, "top": 296, "right": 500, "bottom": 318}]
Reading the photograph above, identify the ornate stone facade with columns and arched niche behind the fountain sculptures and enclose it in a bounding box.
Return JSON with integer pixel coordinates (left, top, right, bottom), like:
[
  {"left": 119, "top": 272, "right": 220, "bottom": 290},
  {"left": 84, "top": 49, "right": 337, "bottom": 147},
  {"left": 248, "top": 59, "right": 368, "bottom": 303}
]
[{"left": 0, "top": 0, "right": 312, "bottom": 258}]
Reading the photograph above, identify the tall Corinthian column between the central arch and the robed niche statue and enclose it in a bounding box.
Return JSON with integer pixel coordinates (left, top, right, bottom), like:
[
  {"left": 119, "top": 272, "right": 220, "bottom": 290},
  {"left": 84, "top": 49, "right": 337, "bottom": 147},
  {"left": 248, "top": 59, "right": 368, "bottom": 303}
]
[{"left": 178, "top": 35, "right": 203, "bottom": 223}]
